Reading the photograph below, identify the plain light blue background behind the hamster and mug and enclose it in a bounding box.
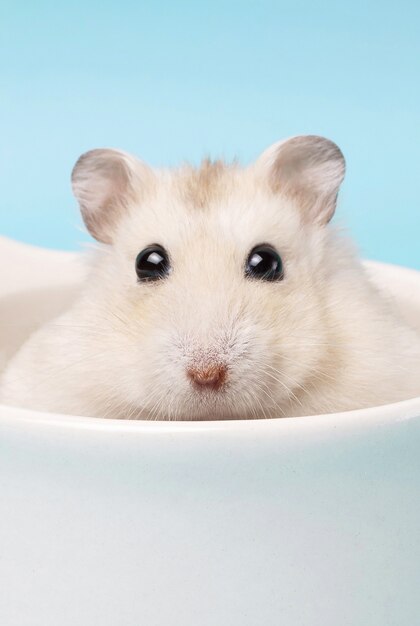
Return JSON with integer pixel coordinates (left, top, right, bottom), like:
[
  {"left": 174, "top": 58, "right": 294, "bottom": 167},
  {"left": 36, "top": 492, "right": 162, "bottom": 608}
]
[{"left": 0, "top": 0, "right": 420, "bottom": 268}]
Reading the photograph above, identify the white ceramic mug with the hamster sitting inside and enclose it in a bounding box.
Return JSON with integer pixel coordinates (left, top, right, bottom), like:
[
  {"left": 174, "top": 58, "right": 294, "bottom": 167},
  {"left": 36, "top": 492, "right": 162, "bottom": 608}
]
[{"left": 0, "top": 240, "right": 420, "bottom": 626}]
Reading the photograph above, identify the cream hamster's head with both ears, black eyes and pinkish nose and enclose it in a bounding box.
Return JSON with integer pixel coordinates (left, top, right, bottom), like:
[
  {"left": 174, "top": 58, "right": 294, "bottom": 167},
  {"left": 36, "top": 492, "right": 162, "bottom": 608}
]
[{"left": 72, "top": 136, "right": 344, "bottom": 420}]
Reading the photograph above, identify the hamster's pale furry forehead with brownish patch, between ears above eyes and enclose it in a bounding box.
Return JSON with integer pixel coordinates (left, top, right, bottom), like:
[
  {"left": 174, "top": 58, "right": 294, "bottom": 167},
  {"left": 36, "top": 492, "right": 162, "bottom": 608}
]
[{"left": 116, "top": 161, "right": 301, "bottom": 254}]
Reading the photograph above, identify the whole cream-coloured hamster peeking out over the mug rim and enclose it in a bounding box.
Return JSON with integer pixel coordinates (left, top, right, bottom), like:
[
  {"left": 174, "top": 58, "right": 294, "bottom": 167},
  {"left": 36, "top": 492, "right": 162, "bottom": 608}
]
[{"left": 1, "top": 136, "right": 420, "bottom": 420}]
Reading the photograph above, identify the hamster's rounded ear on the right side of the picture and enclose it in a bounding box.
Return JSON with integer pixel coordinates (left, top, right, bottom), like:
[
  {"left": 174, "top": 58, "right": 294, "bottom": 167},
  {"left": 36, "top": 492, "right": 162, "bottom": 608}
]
[{"left": 257, "top": 135, "right": 345, "bottom": 224}]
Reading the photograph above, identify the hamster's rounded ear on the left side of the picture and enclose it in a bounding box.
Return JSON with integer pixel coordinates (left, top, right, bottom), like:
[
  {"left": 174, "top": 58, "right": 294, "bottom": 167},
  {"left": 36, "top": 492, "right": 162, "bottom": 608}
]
[{"left": 71, "top": 148, "right": 150, "bottom": 243}]
